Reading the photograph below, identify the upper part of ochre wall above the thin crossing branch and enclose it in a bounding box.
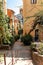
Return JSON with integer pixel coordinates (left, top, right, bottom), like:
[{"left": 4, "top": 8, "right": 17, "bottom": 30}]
[{"left": 23, "top": 0, "right": 43, "bottom": 17}]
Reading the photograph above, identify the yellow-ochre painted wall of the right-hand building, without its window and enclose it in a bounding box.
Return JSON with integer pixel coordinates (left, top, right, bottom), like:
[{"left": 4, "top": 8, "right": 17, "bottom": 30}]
[{"left": 23, "top": 0, "right": 43, "bottom": 36}]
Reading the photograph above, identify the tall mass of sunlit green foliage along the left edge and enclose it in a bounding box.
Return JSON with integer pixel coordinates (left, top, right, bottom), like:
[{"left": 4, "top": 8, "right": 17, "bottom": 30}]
[{"left": 0, "top": 9, "right": 12, "bottom": 44}]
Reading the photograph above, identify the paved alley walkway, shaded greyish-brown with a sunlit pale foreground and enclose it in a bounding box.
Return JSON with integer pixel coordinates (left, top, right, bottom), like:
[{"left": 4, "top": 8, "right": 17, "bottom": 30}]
[{"left": 0, "top": 41, "right": 34, "bottom": 65}]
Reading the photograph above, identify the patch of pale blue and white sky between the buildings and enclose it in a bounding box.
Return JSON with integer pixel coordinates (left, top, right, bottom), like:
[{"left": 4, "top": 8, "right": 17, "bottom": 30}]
[{"left": 7, "top": 0, "right": 23, "bottom": 14}]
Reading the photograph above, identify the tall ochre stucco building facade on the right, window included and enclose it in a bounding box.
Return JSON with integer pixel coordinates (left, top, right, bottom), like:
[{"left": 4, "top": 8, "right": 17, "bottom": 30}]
[{"left": 23, "top": 0, "right": 43, "bottom": 40}]
